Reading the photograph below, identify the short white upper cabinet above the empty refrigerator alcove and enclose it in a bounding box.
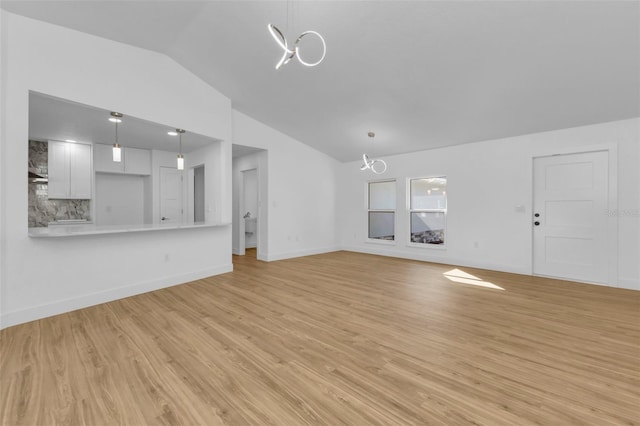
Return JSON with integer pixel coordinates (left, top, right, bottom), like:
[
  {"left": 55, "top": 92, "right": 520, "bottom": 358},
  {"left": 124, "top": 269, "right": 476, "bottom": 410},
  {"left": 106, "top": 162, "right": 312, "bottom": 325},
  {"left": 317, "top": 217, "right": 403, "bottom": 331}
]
[{"left": 93, "top": 144, "right": 151, "bottom": 176}]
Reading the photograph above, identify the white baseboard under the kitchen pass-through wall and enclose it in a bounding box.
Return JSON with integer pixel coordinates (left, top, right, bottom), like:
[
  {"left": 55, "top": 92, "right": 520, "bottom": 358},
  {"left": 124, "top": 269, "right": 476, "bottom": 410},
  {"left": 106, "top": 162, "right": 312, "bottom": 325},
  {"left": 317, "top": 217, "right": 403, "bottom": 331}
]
[{"left": 0, "top": 263, "right": 233, "bottom": 329}]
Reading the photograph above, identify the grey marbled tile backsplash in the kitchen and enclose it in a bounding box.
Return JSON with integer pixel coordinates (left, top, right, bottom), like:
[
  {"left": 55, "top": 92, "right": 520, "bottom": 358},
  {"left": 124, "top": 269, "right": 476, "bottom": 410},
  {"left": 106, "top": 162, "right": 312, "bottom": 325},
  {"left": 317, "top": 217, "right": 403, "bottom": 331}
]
[{"left": 28, "top": 140, "right": 91, "bottom": 228}]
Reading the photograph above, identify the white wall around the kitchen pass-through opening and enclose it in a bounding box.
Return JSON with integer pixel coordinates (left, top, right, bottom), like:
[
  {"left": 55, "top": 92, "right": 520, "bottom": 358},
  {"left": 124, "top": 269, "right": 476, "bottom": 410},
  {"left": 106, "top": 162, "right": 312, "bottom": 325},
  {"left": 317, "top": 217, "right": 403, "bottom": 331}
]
[{"left": 0, "top": 11, "right": 232, "bottom": 327}]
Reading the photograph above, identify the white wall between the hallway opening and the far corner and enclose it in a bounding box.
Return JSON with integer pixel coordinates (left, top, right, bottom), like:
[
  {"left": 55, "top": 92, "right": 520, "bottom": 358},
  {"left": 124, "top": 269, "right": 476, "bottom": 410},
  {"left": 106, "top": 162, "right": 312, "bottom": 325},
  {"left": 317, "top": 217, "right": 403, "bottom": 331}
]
[{"left": 232, "top": 110, "right": 340, "bottom": 260}]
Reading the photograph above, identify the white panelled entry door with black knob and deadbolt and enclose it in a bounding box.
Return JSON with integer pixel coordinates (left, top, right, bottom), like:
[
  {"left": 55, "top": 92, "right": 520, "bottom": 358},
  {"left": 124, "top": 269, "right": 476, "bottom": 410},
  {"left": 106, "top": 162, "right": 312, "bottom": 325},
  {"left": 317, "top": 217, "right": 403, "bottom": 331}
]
[{"left": 532, "top": 151, "right": 609, "bottom": 284}]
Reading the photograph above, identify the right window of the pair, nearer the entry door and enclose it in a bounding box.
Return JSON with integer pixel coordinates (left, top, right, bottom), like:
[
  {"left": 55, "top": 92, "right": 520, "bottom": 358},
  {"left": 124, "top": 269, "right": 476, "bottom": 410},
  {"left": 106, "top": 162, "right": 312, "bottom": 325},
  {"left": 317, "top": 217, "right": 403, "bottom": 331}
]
[{"left": 409, "top": 176, "right": 447, "bottom": 244}]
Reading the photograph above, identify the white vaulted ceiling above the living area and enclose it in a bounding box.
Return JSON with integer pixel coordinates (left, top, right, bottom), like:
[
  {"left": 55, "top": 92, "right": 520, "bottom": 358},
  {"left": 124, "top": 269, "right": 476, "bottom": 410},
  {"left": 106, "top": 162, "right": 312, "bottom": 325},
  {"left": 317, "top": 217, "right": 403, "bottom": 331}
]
[{"left": 2, "top": 0, "right": 640, "bottom": 161}]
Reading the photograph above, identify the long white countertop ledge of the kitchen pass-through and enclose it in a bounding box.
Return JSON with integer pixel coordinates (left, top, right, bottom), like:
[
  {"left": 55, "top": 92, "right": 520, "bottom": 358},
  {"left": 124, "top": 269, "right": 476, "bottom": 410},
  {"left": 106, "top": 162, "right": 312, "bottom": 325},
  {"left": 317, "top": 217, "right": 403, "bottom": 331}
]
[{"left": 29, "top": 222, "right": 231, "bottom": 238}]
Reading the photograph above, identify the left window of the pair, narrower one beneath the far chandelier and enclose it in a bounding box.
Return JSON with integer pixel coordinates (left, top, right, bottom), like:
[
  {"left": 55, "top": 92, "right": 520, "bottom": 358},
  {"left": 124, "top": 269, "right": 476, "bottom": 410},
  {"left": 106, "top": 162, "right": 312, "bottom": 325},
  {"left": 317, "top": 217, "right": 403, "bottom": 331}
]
[{"left": 368, "top": 180, "right": 396, "bottom": 241}]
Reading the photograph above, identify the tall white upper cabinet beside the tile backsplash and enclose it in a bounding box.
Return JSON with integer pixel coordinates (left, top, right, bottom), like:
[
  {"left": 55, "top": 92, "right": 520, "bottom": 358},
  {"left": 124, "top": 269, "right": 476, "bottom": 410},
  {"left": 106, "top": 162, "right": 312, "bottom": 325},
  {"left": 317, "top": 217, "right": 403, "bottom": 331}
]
[{"left": 48, "top": 141, "right": 93, "bottom": 200}]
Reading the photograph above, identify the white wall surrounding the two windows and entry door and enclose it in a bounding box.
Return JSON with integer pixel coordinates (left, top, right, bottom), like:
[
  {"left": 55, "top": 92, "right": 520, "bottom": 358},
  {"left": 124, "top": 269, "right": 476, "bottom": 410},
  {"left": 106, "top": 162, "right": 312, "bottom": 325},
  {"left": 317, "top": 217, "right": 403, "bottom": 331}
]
[{"left": 338, "top": 119, "right": 640, "bottom": 290}]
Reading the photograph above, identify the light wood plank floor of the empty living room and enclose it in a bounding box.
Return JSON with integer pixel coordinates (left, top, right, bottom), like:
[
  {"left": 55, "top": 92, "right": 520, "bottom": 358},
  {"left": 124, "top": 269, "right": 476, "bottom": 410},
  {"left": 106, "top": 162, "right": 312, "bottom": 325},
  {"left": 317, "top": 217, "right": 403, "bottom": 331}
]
[{"left": 0, "top": 252, "right": 640, "bottom": 426}]
